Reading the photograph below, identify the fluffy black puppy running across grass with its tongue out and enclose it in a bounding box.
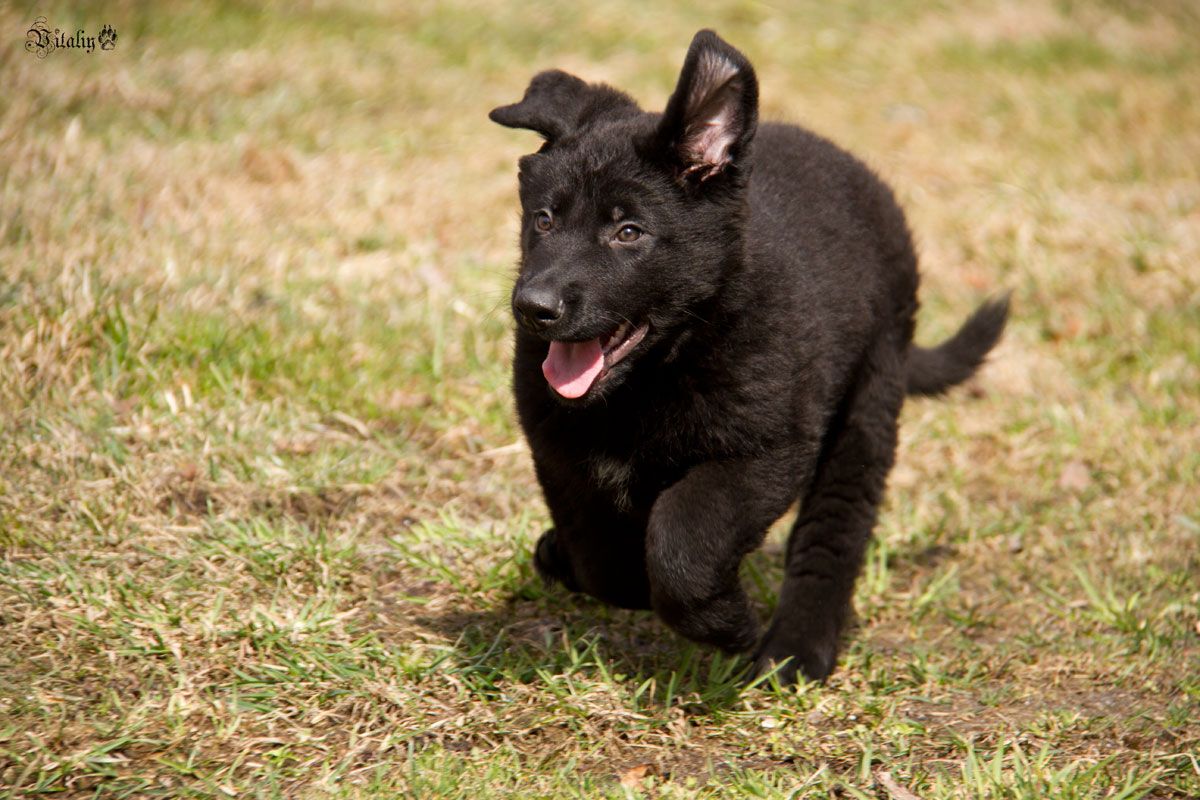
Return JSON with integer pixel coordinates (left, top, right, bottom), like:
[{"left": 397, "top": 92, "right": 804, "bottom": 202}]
[{"left": 491, "top": 30, "right": 1008, "bottom": 681}]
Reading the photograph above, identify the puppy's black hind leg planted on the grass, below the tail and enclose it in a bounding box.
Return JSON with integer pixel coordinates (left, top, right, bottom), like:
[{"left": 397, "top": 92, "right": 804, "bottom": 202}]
[{"left": 756, "top": 339, "right": 905, "bottom": 684}]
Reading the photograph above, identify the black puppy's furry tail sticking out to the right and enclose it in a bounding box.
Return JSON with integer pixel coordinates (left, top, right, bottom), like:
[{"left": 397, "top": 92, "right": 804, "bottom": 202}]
[{"left": 907, "top": 294, "right": 1010, "bottom": 395}]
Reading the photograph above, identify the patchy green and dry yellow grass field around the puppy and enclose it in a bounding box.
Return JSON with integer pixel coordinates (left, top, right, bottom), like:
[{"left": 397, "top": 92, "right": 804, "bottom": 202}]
[{"left": 0, "top": 0, "right": 1200, "bottom": 800}]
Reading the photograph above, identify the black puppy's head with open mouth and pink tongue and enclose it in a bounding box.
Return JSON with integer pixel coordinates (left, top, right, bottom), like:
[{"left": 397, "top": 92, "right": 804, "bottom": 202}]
[{"left": 491, "top": 30, "right": 758, "bottom": 403}]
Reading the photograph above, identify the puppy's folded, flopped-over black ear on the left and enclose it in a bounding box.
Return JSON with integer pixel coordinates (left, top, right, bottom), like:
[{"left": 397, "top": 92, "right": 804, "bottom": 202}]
[{"left": 488, "top": 70, "right": 637, "bottom": 144}]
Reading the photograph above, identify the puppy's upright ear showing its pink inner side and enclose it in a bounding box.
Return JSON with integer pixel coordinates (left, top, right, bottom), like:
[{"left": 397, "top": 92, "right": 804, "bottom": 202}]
[{"left": 659, "top": 30, "right": 758, "bottom": 181}]
